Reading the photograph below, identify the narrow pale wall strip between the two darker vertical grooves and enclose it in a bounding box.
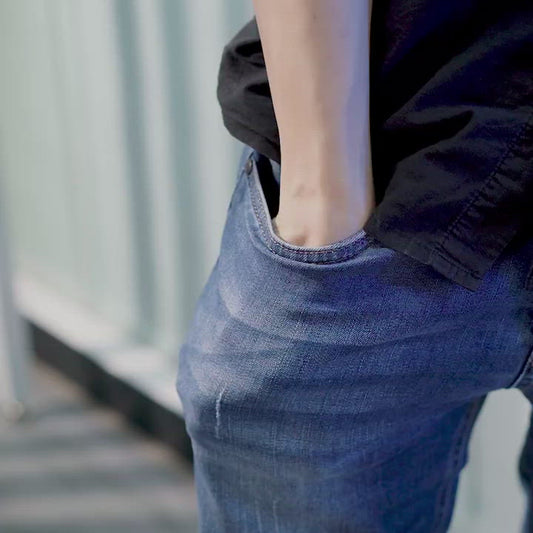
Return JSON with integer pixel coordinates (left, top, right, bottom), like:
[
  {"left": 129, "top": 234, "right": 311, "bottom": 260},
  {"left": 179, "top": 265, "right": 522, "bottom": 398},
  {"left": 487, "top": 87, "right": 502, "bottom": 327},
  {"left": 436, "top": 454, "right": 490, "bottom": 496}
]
[{"left": 130, "top": 0, "right": 181, "bottom": 350}]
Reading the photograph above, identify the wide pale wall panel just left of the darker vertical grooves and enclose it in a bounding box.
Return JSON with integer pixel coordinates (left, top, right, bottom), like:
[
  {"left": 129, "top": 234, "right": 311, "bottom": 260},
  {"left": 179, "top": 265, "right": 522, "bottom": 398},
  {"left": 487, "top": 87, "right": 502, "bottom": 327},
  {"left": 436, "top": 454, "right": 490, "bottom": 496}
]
[{"left": 53, "top": 0, "right": 138, "bottom": 327}]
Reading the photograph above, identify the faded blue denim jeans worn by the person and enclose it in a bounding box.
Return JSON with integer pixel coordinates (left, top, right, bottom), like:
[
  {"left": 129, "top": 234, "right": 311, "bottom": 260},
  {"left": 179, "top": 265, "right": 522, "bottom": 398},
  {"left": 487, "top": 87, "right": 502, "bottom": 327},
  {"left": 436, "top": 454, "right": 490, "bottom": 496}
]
[{"left": 176, "top": 145, "right": 533, "bottom": 533}]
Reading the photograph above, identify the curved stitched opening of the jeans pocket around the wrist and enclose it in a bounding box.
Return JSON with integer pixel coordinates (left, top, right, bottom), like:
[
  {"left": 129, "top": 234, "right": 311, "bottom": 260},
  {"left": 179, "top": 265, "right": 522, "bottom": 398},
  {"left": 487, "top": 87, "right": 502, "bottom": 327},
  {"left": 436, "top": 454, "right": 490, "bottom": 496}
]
[{"left": 245, "top": 149, "right": 374, "bottom": 264}]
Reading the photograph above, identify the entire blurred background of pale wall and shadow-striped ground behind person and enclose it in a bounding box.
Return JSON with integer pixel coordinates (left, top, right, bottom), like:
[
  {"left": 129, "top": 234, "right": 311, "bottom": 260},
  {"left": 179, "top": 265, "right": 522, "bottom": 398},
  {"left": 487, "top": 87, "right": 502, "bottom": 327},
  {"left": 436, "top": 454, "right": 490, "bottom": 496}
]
[{"left": 0, "top": 0, "right": 530, "bottom": 533}]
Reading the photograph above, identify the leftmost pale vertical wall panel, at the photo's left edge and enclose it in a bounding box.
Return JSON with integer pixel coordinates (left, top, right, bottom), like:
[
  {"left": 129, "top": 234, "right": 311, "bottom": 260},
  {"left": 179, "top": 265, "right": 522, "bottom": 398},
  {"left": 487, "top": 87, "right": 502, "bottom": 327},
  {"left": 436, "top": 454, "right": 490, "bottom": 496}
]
[{"left": 0, "top": 0, "right": 74, "bottom": 290}]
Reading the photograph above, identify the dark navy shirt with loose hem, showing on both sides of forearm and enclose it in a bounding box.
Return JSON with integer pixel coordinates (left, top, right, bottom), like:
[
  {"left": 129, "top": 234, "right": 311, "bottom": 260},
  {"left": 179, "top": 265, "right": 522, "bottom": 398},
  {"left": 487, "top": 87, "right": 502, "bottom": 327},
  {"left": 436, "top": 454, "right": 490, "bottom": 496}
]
[{"left": 217, "top": 0, "right": 533, "bottom": 291}]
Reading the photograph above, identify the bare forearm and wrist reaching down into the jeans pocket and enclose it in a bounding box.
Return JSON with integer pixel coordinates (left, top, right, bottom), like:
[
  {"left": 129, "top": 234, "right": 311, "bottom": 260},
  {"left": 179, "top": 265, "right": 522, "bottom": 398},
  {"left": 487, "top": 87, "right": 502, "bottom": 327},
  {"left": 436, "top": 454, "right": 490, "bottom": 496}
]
[{"left": 253, "top": 0, "right": 375, "bottom": 246}]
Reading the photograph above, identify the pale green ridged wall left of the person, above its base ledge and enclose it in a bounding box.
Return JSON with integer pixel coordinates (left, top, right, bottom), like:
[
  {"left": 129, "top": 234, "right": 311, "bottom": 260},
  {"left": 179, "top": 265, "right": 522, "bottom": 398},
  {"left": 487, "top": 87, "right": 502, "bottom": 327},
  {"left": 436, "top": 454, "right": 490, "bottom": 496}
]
[{"left": 0, "top": 0, "right": 252, "bottom": 350}]
